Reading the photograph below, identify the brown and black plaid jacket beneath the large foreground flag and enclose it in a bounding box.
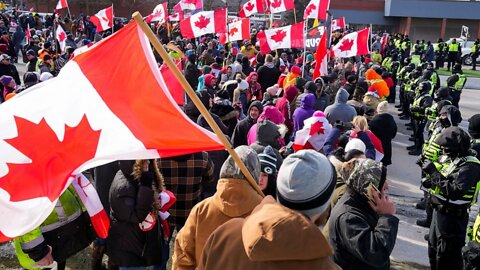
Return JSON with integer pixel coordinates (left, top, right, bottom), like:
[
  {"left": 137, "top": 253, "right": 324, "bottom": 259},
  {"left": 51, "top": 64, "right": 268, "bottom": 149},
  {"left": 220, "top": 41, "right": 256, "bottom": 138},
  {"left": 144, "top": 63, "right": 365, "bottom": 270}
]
[{"left": 158, "top": 152, "right": 214, "bottom": 226}]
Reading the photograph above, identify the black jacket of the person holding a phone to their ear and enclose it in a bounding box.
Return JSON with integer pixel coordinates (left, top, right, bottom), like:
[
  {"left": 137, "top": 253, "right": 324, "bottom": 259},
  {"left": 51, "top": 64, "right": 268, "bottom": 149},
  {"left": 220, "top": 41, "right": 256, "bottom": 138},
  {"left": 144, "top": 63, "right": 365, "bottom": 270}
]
[{"left": 328, "top": 189, "right": 398, "bottom": 270}]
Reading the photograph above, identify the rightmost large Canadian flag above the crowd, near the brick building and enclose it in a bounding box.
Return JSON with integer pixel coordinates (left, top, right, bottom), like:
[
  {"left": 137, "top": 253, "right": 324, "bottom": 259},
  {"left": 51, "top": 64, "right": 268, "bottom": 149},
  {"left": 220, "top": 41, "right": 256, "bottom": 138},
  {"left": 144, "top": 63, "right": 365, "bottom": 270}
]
[{"left": 332, "top": 28, "right": 370, "bottom": 57}]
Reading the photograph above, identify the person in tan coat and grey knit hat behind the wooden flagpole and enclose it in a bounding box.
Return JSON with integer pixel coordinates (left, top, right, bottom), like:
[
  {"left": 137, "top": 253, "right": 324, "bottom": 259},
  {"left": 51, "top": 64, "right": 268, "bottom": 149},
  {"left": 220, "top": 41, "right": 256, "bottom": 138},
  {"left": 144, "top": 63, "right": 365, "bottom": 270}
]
[{"left": 172, "top": 145, "right": 262, "bottom": 270}]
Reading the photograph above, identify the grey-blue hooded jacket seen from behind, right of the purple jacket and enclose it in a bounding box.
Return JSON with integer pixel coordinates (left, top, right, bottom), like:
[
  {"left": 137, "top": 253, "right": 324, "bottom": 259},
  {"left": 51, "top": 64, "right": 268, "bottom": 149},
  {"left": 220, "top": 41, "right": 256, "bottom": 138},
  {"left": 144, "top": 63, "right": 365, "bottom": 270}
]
[{"left": 325, "top": 89, "right": 357, "bottom": 124}]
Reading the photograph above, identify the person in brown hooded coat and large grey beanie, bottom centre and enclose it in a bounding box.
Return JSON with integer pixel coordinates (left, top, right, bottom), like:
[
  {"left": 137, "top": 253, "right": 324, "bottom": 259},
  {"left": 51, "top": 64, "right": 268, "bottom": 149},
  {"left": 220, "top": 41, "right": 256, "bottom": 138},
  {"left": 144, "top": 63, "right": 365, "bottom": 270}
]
[{"left": 199, "top": 150, "right": 340, "bottom": 270}]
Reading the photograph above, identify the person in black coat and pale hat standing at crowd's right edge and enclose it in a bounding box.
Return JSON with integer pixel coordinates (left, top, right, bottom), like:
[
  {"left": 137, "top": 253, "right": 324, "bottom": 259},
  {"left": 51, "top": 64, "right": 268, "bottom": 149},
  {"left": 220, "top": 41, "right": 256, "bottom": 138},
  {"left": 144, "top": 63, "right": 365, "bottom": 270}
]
[{"left": 368, "top": 101, "right": 397, "bottom": 166}]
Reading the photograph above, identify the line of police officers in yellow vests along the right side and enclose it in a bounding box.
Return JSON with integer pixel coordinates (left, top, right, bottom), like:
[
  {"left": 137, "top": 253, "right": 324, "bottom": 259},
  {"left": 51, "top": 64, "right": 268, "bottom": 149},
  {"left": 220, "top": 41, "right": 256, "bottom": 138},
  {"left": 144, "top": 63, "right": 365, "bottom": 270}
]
[{"left": 390, "top": 34, "right": 480, "bottom": 269}]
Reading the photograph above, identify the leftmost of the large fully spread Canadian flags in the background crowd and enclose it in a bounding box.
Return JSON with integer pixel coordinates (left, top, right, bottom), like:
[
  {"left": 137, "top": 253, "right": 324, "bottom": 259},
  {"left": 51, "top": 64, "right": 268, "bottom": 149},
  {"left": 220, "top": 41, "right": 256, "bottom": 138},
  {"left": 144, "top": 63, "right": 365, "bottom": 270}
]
[{"left": 180, "top": 8, "right": 227, "bottom": 38}]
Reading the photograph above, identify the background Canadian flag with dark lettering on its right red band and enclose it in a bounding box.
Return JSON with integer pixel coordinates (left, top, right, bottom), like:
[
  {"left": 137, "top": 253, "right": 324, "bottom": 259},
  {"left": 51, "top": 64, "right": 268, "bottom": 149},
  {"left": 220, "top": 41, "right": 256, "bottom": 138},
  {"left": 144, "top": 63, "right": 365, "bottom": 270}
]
[{"left": 257, "top": 22, "right": 304, "bottom": 54}]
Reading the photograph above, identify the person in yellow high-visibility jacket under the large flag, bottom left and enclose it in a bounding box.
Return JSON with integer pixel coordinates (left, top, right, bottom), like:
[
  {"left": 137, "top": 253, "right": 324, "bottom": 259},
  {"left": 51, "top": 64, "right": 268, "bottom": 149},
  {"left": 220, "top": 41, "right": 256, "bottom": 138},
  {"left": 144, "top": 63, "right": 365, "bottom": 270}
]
[{"left": 13, "top": 186, "right": 95, "bottom": 270}]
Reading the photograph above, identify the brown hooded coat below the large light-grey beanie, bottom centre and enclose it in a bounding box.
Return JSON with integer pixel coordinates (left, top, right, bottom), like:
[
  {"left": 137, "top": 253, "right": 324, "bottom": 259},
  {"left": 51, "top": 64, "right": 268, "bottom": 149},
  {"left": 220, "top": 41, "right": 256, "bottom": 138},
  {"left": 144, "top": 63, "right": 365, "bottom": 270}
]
[{"left": 199, "top": 196, "right": 340, "bottom": 270}]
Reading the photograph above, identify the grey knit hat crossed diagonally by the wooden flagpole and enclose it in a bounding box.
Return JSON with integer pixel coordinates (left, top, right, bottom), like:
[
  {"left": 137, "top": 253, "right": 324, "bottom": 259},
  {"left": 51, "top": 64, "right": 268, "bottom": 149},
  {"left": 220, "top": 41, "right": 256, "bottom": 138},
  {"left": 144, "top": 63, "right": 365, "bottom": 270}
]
[{"left": 220, "top": 145, "right": 260, "bottom": 183}]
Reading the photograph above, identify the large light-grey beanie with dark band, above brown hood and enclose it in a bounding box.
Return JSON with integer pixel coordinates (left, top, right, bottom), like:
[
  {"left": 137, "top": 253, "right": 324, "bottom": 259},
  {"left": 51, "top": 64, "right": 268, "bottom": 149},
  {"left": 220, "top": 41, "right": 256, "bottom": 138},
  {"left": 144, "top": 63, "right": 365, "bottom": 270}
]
[{"left": 277, "top": 150, "right": 337, "bottom": 217}]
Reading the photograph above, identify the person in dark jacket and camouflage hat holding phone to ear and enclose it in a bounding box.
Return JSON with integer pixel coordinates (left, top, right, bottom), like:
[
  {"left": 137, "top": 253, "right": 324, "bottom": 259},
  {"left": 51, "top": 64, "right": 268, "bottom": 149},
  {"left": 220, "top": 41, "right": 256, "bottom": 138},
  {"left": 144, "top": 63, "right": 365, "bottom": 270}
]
[{"left": 327, "top": 159, "right": 399, "bottom": 270}]
